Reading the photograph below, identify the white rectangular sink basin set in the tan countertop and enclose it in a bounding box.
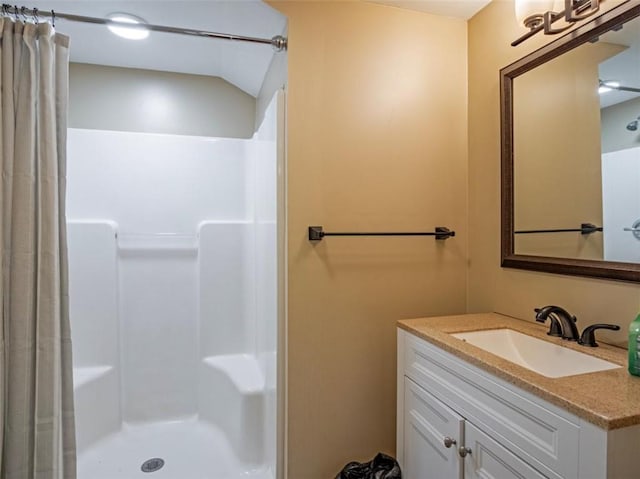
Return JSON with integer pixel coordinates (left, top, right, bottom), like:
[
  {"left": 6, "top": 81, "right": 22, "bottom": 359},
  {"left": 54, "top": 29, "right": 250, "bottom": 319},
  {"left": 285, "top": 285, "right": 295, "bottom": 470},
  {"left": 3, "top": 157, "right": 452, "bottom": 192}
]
[{"left": 451, "top": 328, "right": 621, "bottom": 378}]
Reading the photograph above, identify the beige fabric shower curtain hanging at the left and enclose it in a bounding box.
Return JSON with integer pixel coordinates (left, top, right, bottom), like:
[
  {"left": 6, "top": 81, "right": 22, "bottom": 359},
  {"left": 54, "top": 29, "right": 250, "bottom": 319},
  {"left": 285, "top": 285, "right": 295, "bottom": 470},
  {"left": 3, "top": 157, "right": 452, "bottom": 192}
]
[{"left": 0, "top": 18, "right": 76, "bottom": 479}]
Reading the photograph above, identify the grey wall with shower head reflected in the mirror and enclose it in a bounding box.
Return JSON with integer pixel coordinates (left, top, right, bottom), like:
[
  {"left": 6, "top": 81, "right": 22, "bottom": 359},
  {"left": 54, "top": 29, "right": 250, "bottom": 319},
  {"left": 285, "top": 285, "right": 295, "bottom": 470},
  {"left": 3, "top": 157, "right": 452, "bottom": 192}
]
[{"left": 602, "top": 98, "right": 640, "bottom": 153}]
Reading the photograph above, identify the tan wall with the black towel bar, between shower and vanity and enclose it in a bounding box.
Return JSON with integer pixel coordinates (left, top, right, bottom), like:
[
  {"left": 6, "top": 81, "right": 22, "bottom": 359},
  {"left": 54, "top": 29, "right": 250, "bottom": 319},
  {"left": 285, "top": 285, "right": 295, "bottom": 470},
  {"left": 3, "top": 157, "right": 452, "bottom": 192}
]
[{"left": 271, "top": 2, "right": 468, "bottom": 479}]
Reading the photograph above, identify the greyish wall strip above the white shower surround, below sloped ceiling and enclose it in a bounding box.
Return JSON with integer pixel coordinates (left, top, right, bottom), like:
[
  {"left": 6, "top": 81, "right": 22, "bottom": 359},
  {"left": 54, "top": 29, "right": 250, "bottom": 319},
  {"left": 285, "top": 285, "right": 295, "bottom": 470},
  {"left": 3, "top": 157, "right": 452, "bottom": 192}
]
[{"left": 69, "top": 63, "right": 256, "bottom": 138}]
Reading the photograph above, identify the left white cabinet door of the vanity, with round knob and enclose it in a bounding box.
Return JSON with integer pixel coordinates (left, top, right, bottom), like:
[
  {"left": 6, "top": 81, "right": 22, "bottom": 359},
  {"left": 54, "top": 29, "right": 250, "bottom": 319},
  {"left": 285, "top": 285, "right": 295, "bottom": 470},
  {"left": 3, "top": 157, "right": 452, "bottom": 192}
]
[{"left": 402, "top": 377, "right": 464, "bottom": 479}]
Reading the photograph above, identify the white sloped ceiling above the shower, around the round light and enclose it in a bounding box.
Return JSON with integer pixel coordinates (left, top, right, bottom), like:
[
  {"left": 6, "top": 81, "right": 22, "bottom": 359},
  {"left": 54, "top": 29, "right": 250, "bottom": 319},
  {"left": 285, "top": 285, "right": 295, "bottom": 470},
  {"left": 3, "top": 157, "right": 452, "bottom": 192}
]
[{"left": 28, "top": 0, "right": 286, "bottom": 96}]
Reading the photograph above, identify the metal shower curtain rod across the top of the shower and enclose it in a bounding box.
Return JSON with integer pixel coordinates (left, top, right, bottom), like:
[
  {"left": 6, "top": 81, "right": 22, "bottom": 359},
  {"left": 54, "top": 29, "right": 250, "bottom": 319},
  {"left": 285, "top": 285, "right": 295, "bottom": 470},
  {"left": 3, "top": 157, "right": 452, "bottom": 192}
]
[{"left": 2, "top": 4, "right": 287, "bottom": 52}]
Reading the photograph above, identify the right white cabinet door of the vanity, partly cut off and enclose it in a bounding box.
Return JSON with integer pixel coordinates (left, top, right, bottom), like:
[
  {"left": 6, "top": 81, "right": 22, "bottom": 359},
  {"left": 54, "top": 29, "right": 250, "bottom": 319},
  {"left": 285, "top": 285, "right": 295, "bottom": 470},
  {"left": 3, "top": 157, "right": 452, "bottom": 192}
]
[{"left": 464, "top": 422, "right": 547, "bottom": 479}]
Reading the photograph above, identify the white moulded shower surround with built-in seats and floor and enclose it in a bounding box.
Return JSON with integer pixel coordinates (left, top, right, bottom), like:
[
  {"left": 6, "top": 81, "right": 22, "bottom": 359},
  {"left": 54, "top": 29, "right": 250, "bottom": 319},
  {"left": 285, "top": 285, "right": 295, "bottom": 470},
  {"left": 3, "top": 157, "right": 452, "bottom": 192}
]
[{"left": 67, "top": 95, "right": 277, "bottom": 479}]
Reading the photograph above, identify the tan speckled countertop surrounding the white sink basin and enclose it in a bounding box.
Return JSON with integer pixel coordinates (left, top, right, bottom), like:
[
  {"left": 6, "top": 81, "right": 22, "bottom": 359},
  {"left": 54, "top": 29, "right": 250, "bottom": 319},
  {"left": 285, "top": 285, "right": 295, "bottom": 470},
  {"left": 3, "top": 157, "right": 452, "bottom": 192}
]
[{"left": 398, "top": 313, "right": 640, "bottom": 429}]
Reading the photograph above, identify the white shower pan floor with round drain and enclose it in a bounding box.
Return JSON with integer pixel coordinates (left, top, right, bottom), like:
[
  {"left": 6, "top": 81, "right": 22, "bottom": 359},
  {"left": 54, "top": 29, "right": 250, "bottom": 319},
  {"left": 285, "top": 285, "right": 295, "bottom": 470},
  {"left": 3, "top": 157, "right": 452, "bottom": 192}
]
[{"left": 78, "top": 418, "right": 273, "bottom": 479}]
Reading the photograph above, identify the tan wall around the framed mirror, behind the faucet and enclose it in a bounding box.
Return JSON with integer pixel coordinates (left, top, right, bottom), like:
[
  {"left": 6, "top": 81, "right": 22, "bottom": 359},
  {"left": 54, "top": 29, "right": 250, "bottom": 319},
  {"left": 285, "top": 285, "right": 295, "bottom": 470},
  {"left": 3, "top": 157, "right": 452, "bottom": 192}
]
[{"left": 468, "top": 0, "right": 640, "bottom": 343}]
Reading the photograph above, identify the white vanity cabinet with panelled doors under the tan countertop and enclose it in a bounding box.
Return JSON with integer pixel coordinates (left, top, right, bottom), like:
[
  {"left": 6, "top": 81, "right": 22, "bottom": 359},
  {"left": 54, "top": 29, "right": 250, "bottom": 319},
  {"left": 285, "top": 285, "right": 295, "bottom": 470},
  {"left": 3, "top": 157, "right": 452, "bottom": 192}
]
[{"left": 397, "top": 329, "right": 640, "bottom": 479}]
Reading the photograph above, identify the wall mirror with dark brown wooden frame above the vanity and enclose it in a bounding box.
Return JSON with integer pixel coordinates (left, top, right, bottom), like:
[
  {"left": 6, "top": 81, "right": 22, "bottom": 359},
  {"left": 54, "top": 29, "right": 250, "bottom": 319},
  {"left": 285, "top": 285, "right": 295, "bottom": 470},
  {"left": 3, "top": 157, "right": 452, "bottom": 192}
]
[{"left": 500, "top": 2, "right": 640, "bottom": 282}]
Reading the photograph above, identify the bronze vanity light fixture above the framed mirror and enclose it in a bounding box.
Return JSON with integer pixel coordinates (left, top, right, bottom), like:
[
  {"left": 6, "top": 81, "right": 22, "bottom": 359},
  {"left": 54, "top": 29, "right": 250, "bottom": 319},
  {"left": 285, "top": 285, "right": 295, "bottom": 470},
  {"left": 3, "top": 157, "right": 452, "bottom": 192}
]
[{"left": 511, "top": 0, "right": 604, "bottom": 47}]
